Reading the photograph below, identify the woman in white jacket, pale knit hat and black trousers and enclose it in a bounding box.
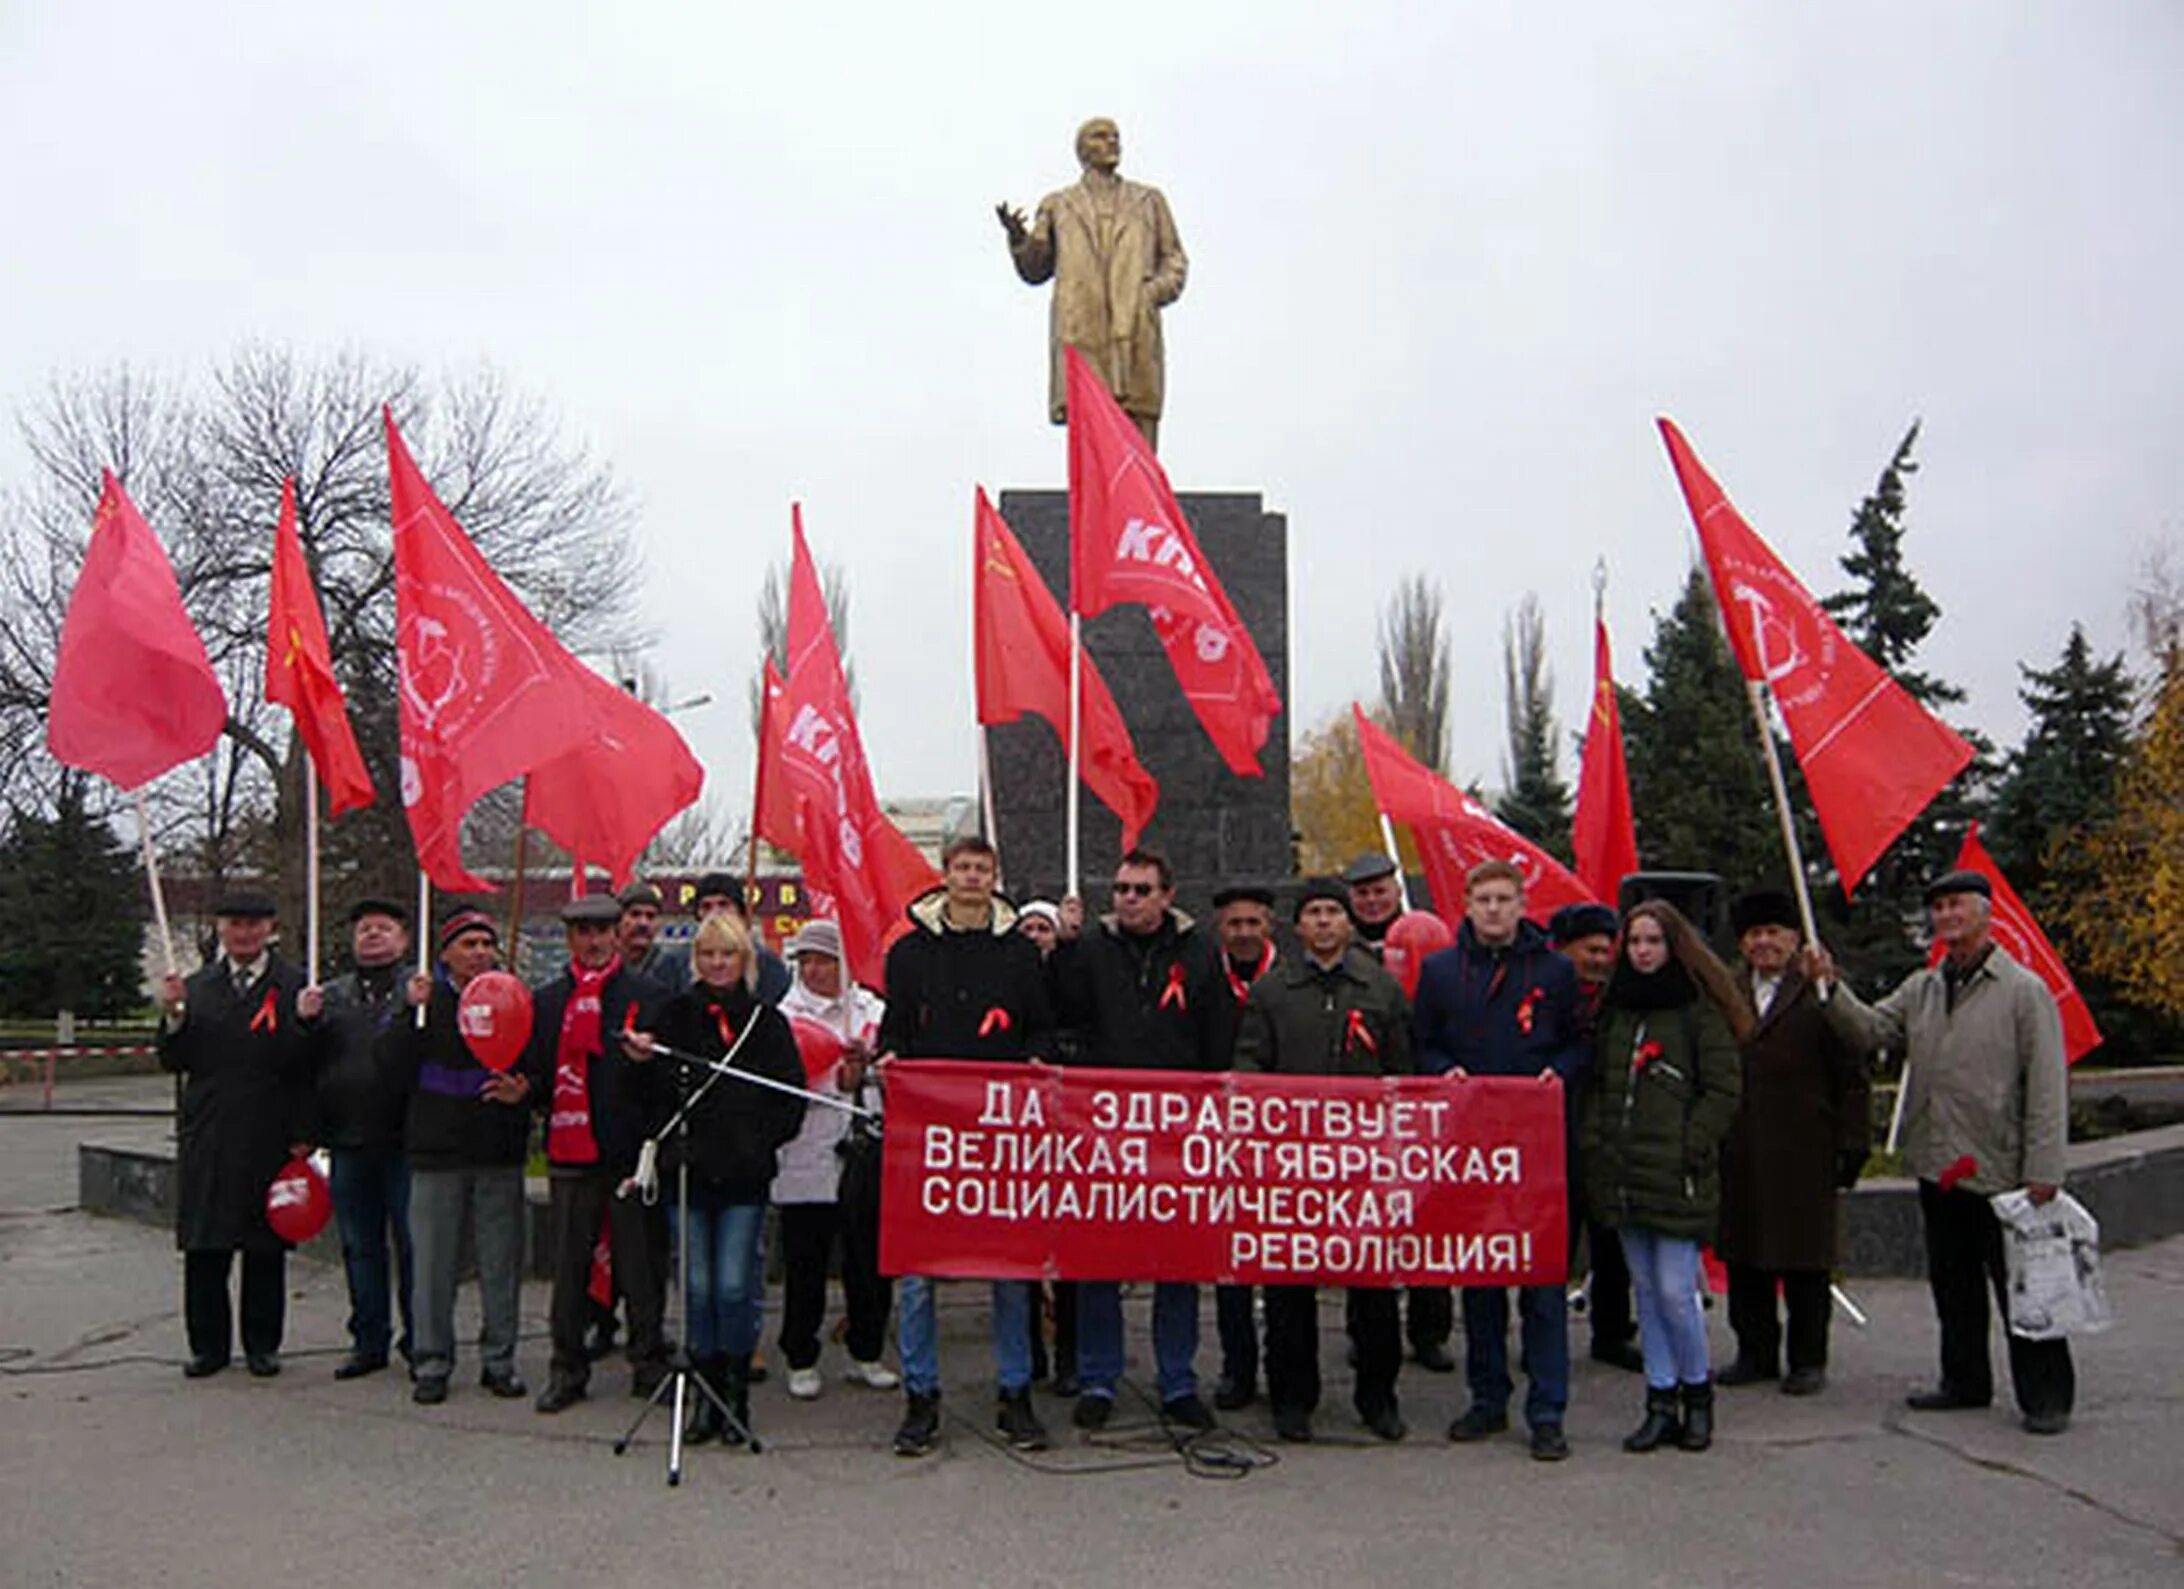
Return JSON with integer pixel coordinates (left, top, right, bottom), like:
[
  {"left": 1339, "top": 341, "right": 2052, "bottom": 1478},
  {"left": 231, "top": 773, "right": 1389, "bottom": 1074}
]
[{"left": 773, "top": 921, "right": 902, "bottom": 1401}]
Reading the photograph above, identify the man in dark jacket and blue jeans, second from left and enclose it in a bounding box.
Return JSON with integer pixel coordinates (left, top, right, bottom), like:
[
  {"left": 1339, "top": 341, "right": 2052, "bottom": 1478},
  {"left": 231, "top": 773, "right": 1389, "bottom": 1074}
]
[{"left": 319, "top": 899, "right": 411, "bottom": 1379}]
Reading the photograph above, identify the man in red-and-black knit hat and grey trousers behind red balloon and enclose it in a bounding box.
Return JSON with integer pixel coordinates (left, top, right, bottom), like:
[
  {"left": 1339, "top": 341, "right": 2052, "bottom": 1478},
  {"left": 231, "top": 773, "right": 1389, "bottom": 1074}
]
[{"left": 380, "top": 910, "right": 531, "bottom": 1406}]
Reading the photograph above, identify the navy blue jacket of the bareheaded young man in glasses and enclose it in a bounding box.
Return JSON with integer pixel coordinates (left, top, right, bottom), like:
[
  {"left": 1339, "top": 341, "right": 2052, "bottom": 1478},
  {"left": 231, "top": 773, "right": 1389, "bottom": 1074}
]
[{"left": 1411, "top": 921, "right": 1592, "bottom": 1107}]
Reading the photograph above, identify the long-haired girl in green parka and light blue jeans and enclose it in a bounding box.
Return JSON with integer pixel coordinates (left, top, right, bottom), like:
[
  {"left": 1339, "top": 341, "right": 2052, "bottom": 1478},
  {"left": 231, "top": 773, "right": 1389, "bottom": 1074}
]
[{"left": 1579, "top": 899, "right": 1752, "bottom": 1451}]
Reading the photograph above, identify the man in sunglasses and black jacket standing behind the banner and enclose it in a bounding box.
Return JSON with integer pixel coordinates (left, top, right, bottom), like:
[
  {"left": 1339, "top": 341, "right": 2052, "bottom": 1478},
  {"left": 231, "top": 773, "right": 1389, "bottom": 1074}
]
[{"left": 1055, "top": 849, "right": 1234, "bottom": 1430}]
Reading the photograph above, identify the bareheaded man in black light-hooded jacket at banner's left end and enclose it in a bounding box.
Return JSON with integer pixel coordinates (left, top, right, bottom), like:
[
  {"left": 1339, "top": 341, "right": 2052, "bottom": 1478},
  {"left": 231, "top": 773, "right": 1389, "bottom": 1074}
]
[{"left": 880, "top": 836, "right": 1055, "bottom": 1456}]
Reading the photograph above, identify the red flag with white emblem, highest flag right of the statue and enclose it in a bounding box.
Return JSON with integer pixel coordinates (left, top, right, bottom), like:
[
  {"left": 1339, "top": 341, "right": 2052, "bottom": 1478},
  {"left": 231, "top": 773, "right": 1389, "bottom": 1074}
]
[{"left": 1660, "top": 419, "right": 1972, "bottom": 897}]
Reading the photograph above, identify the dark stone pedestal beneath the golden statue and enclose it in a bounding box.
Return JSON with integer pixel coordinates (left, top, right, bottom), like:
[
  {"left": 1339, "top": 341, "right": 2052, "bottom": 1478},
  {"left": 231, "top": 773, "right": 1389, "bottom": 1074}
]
[{"left": 992, "top": 491, "right": 1293, "bottom": 912}]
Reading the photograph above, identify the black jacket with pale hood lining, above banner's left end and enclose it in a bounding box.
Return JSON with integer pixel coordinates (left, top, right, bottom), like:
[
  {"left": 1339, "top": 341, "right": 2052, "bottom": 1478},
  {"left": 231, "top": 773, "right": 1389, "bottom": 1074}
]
[{"left": 880, "top": 888, "right": 1055, "bottom": 1059}]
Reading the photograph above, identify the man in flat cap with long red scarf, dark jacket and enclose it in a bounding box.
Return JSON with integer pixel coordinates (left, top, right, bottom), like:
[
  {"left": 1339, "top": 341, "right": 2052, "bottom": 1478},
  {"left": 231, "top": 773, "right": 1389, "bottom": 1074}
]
[{"left": 524, "top": 895, "right": 666, "bottom": 1412}]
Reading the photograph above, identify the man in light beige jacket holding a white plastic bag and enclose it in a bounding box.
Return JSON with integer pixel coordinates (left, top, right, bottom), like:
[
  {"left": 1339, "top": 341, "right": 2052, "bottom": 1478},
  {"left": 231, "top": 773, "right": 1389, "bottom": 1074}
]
[{"left": 1804, "top": 871, "right": 2077, "bottom": 1434}]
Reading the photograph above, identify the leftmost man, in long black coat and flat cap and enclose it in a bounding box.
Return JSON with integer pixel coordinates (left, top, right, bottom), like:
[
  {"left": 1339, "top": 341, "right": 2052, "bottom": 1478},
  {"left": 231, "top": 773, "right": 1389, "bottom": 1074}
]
[{"left": 159, "top": 893, "right": 321, "bottom": 1379}]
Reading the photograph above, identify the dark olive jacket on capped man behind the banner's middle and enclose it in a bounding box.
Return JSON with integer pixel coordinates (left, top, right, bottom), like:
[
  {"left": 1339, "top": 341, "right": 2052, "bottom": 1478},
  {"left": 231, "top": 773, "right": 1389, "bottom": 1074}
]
[{"left": 1236, "top": 947, "right": 1411, "bottom": 1076}]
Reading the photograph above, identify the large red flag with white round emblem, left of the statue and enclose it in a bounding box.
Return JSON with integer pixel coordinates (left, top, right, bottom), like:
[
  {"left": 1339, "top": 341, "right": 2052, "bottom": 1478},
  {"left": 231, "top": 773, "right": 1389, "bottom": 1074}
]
[{"left": 384, "top": 410, "right": 592, "bottom": 893}]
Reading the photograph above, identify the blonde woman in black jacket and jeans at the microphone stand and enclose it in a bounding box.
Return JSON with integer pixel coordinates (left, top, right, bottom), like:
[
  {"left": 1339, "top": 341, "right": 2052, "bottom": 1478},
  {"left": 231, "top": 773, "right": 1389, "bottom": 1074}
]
[{"left": 629, "top": 912, "right": 804, "bottom": 1443}]
